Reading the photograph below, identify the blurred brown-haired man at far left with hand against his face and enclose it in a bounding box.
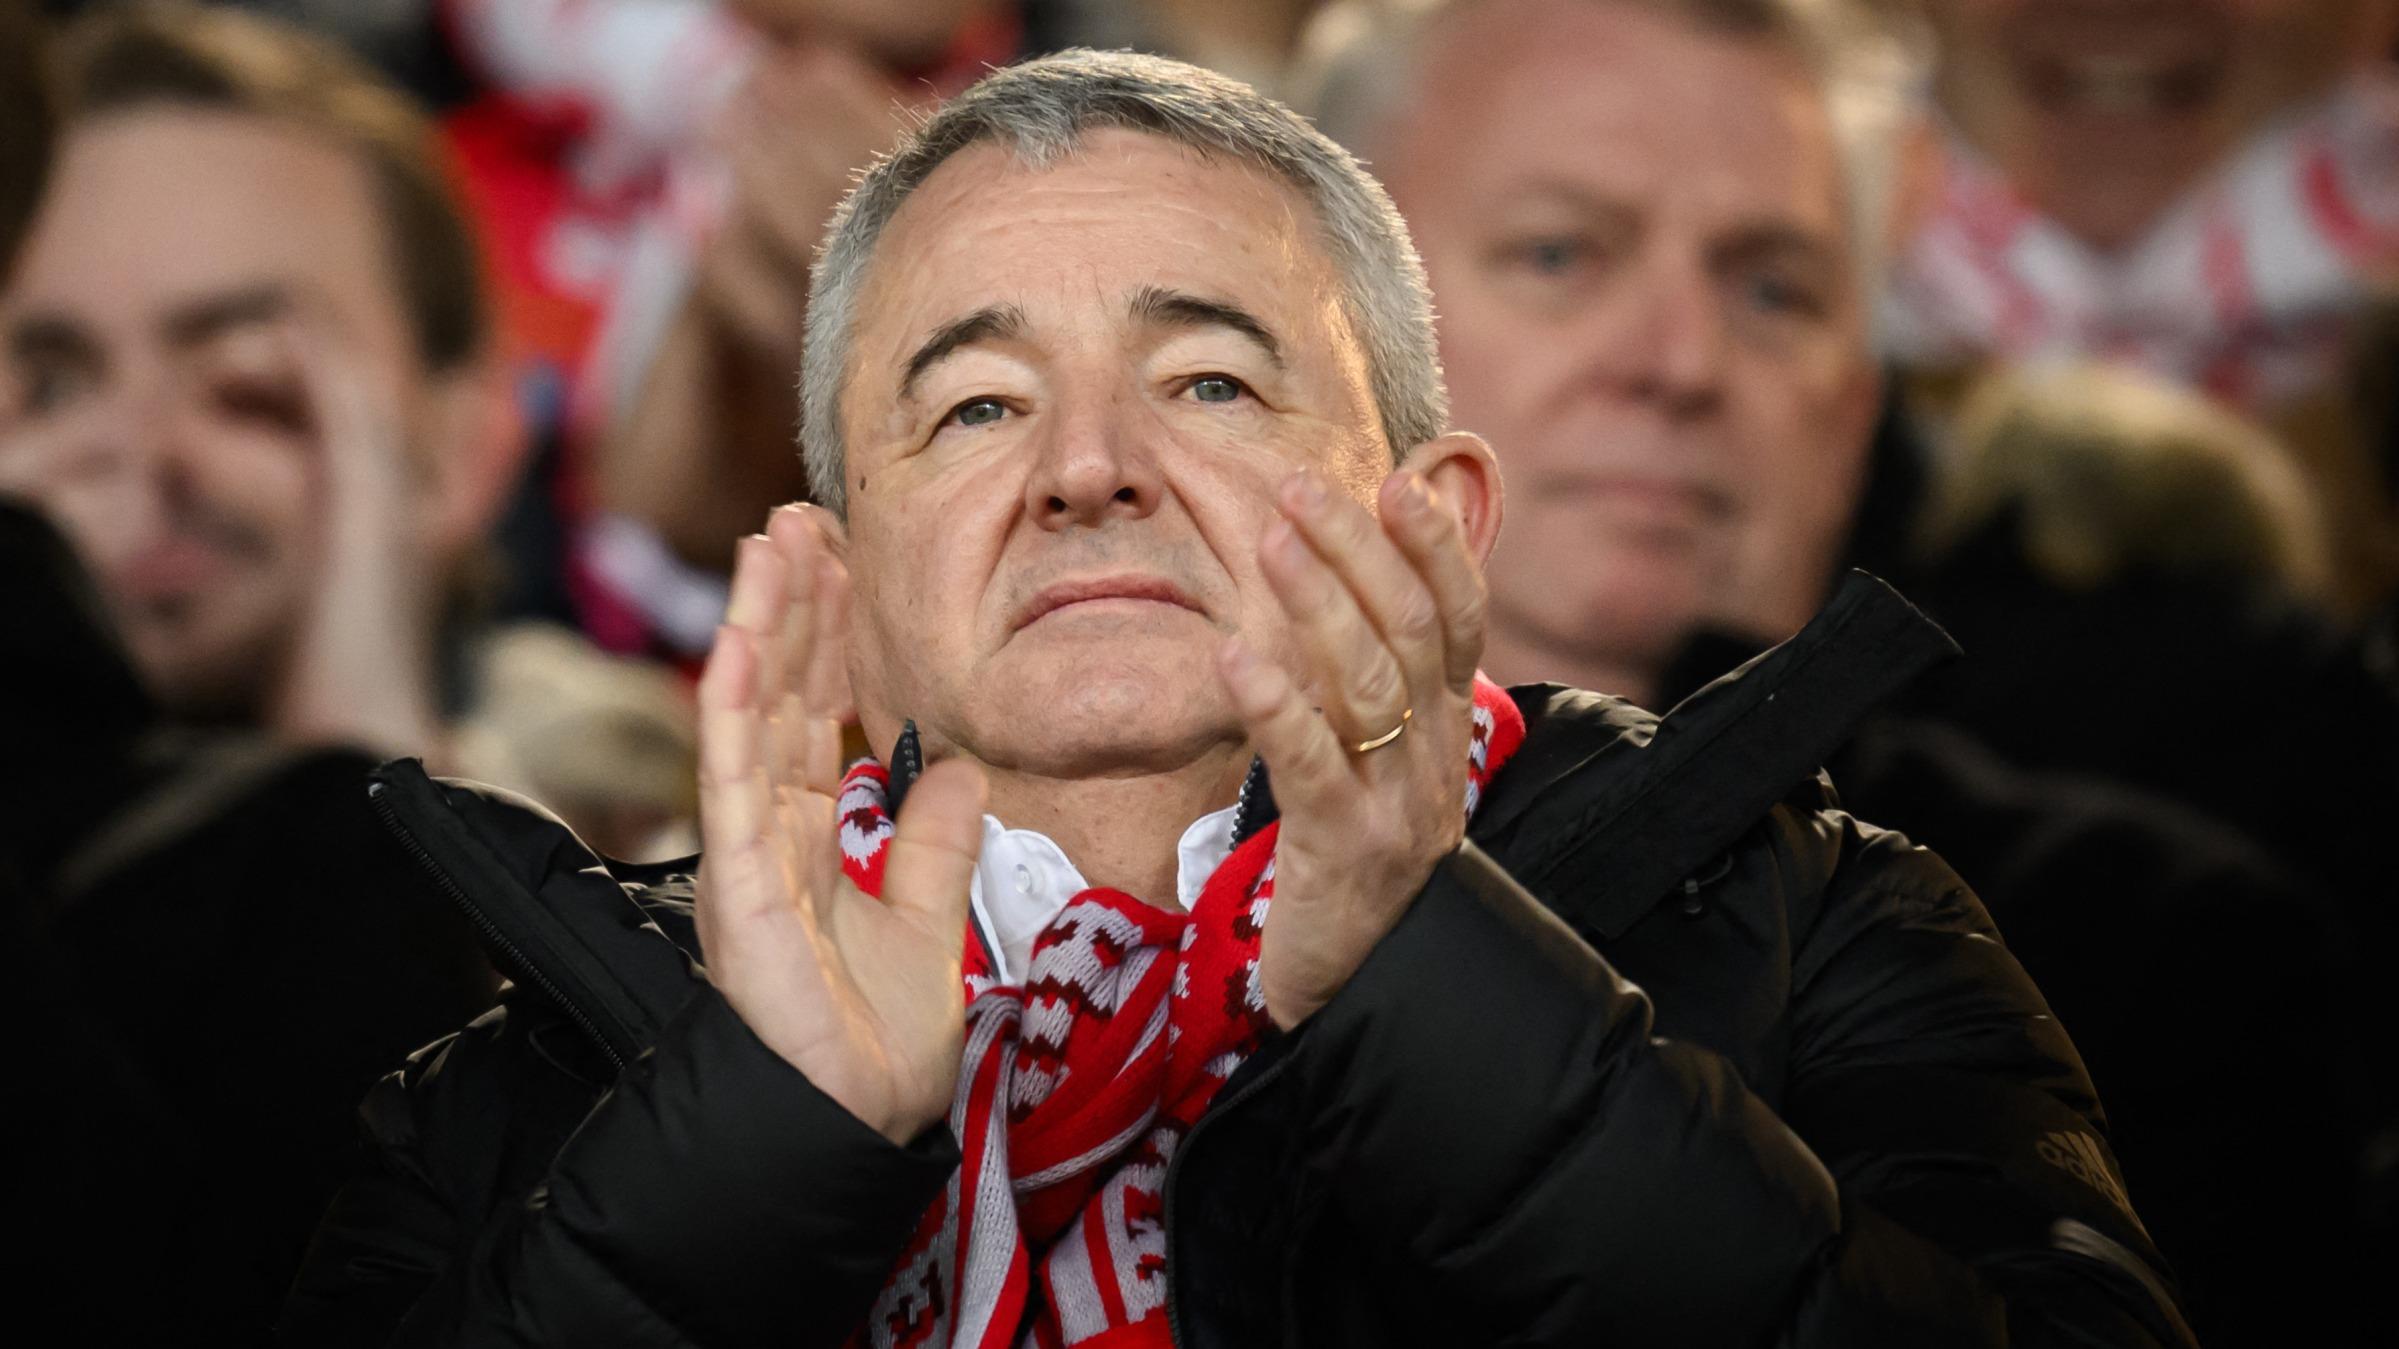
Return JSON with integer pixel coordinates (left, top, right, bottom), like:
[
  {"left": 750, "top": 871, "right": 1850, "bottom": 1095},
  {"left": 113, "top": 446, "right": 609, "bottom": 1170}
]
[{"left": 0, "top": 10, "right": 492, "bottom": 1344}]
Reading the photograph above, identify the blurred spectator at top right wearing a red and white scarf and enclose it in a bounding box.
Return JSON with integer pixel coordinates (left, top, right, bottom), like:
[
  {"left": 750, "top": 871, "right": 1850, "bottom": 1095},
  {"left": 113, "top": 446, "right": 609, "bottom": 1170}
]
[{"left": 1890, "top": 0, "right": 2399, "bottom": 408}]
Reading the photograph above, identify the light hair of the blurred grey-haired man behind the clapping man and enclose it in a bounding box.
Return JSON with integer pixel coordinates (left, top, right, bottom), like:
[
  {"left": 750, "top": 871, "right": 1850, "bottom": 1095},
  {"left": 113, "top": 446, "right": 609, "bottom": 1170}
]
[{"left": 1291, "top": 0, "right": 1929, "bottom": 304}]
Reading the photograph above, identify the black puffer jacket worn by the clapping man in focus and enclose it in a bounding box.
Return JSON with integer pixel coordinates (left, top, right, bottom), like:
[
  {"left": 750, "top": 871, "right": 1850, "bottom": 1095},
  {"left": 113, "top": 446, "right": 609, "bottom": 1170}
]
[{"left": 285, "top": 571, "right": 2188, "bottom": 1349}]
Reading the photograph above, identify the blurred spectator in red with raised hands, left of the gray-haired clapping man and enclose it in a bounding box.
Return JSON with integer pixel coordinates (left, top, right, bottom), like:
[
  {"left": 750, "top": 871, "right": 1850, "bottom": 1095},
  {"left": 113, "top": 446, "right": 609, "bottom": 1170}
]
[{"left": 427, "top": 0, "right": 1022, "bottom": 653}]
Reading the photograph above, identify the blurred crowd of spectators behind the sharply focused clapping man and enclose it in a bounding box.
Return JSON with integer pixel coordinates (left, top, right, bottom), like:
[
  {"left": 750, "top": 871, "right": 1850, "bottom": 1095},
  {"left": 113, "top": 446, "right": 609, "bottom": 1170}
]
[{"left": 0, "top": 0, "right": 2399, "bottom": 1344}]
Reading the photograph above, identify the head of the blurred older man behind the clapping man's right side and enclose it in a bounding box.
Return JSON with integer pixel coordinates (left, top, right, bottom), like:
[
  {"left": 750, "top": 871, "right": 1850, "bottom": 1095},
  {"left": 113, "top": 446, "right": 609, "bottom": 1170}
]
[{"left": 1307, "top": 2, "right": 1898, "bottom": 701}]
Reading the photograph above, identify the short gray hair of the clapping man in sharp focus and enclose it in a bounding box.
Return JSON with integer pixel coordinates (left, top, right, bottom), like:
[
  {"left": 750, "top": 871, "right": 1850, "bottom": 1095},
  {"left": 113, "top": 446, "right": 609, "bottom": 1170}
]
[{"left": 799, "top": 50, "right": 1449, "bottom": 516}]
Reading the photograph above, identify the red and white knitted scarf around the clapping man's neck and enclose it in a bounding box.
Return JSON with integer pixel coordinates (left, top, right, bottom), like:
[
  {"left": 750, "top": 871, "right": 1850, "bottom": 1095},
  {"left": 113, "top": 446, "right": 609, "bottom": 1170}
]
[{"left": 840, "top": 675, "right": 1523, "bottom": 1349}]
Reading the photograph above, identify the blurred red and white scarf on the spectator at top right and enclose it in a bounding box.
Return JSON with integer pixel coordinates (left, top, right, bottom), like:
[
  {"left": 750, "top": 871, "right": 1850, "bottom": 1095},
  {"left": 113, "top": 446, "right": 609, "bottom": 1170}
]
[{"left": 1886, "top": 70, "right": 2399, "bottom": 413}]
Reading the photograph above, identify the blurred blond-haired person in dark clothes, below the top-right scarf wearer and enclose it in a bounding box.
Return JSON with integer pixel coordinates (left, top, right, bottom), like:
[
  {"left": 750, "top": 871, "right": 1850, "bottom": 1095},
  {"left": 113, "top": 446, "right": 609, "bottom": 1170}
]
[{"left": 1910, "top": 362, "right": 2399, "bottom": 939}]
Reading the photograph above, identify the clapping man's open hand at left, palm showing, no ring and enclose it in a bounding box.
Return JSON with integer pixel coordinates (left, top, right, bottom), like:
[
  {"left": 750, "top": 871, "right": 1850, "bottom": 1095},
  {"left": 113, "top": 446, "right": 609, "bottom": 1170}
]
[{"left": 698, "top": 506, "right": 986, "bottom": 1143}]
